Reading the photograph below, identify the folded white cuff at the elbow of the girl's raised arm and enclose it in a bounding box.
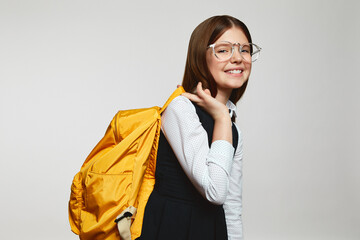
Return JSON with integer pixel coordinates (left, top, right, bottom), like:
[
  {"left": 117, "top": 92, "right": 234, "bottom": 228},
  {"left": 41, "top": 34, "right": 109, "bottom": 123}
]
[{"left": 206, "top": 140, "right": 235, "bottom": 175}]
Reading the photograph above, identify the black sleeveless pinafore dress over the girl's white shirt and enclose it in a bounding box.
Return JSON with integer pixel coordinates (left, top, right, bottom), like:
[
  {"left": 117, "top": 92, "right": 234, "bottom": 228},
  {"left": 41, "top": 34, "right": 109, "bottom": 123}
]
[{"left": 137, "top": 104, "right": 238, "bottom": 240}]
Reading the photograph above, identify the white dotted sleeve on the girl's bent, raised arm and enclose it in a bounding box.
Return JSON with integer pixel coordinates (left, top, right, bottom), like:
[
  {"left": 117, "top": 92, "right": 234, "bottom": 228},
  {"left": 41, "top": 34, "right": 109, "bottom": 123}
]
[{"left": 162, "top": 96, "right": 234, "bottom": 204}]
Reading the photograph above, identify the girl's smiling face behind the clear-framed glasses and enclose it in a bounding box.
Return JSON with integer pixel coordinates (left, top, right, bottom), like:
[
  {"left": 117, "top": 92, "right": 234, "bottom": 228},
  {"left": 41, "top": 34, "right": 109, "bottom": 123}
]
[{"left": 206, "top": 27, "right": 251, "bottom": 99}]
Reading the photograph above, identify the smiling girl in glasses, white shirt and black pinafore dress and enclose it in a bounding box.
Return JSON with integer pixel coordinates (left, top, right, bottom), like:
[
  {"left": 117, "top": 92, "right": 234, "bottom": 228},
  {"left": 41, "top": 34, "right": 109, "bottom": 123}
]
[{"left": 138, "top": 16, "right": 261, "bottom": 240}]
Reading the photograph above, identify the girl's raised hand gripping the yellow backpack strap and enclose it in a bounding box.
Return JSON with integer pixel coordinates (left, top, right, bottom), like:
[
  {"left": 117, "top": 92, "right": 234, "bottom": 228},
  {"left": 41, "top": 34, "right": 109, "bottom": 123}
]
[{"left": 181, "top": 82, "right": 230, "bottom": 121}]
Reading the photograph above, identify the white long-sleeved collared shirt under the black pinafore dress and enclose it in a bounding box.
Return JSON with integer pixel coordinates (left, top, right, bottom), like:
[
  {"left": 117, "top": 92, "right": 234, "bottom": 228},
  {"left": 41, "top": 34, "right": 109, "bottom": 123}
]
[{"left": 161, "top": 96, "right": 243, "bottom": 240}]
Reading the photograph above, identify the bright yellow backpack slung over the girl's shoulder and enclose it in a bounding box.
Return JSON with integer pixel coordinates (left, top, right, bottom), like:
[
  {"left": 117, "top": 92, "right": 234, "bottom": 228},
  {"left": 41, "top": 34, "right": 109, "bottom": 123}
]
[{"left": 69, "top": 87, "right": 185, "bottom": 240}]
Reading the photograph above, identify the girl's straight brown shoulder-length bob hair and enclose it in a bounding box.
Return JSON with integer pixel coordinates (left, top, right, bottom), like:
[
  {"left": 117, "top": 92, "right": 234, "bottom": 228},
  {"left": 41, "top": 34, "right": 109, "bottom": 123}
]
[{"left": 182, "top": 15, "right": 252, "bottom": 104}]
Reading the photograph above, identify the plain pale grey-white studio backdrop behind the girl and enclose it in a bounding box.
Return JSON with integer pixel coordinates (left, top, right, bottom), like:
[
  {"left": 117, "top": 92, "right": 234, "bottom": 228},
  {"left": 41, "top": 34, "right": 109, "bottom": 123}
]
[{"left": 0, "top": 0, "right": 360, "bottom": 240}]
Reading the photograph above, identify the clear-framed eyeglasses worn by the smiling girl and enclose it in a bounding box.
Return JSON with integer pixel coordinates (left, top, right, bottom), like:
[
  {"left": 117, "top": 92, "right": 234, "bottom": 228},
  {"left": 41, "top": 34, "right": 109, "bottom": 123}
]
[{"left": 208, "top": 42, "right": 261, "bottom": 62}]
